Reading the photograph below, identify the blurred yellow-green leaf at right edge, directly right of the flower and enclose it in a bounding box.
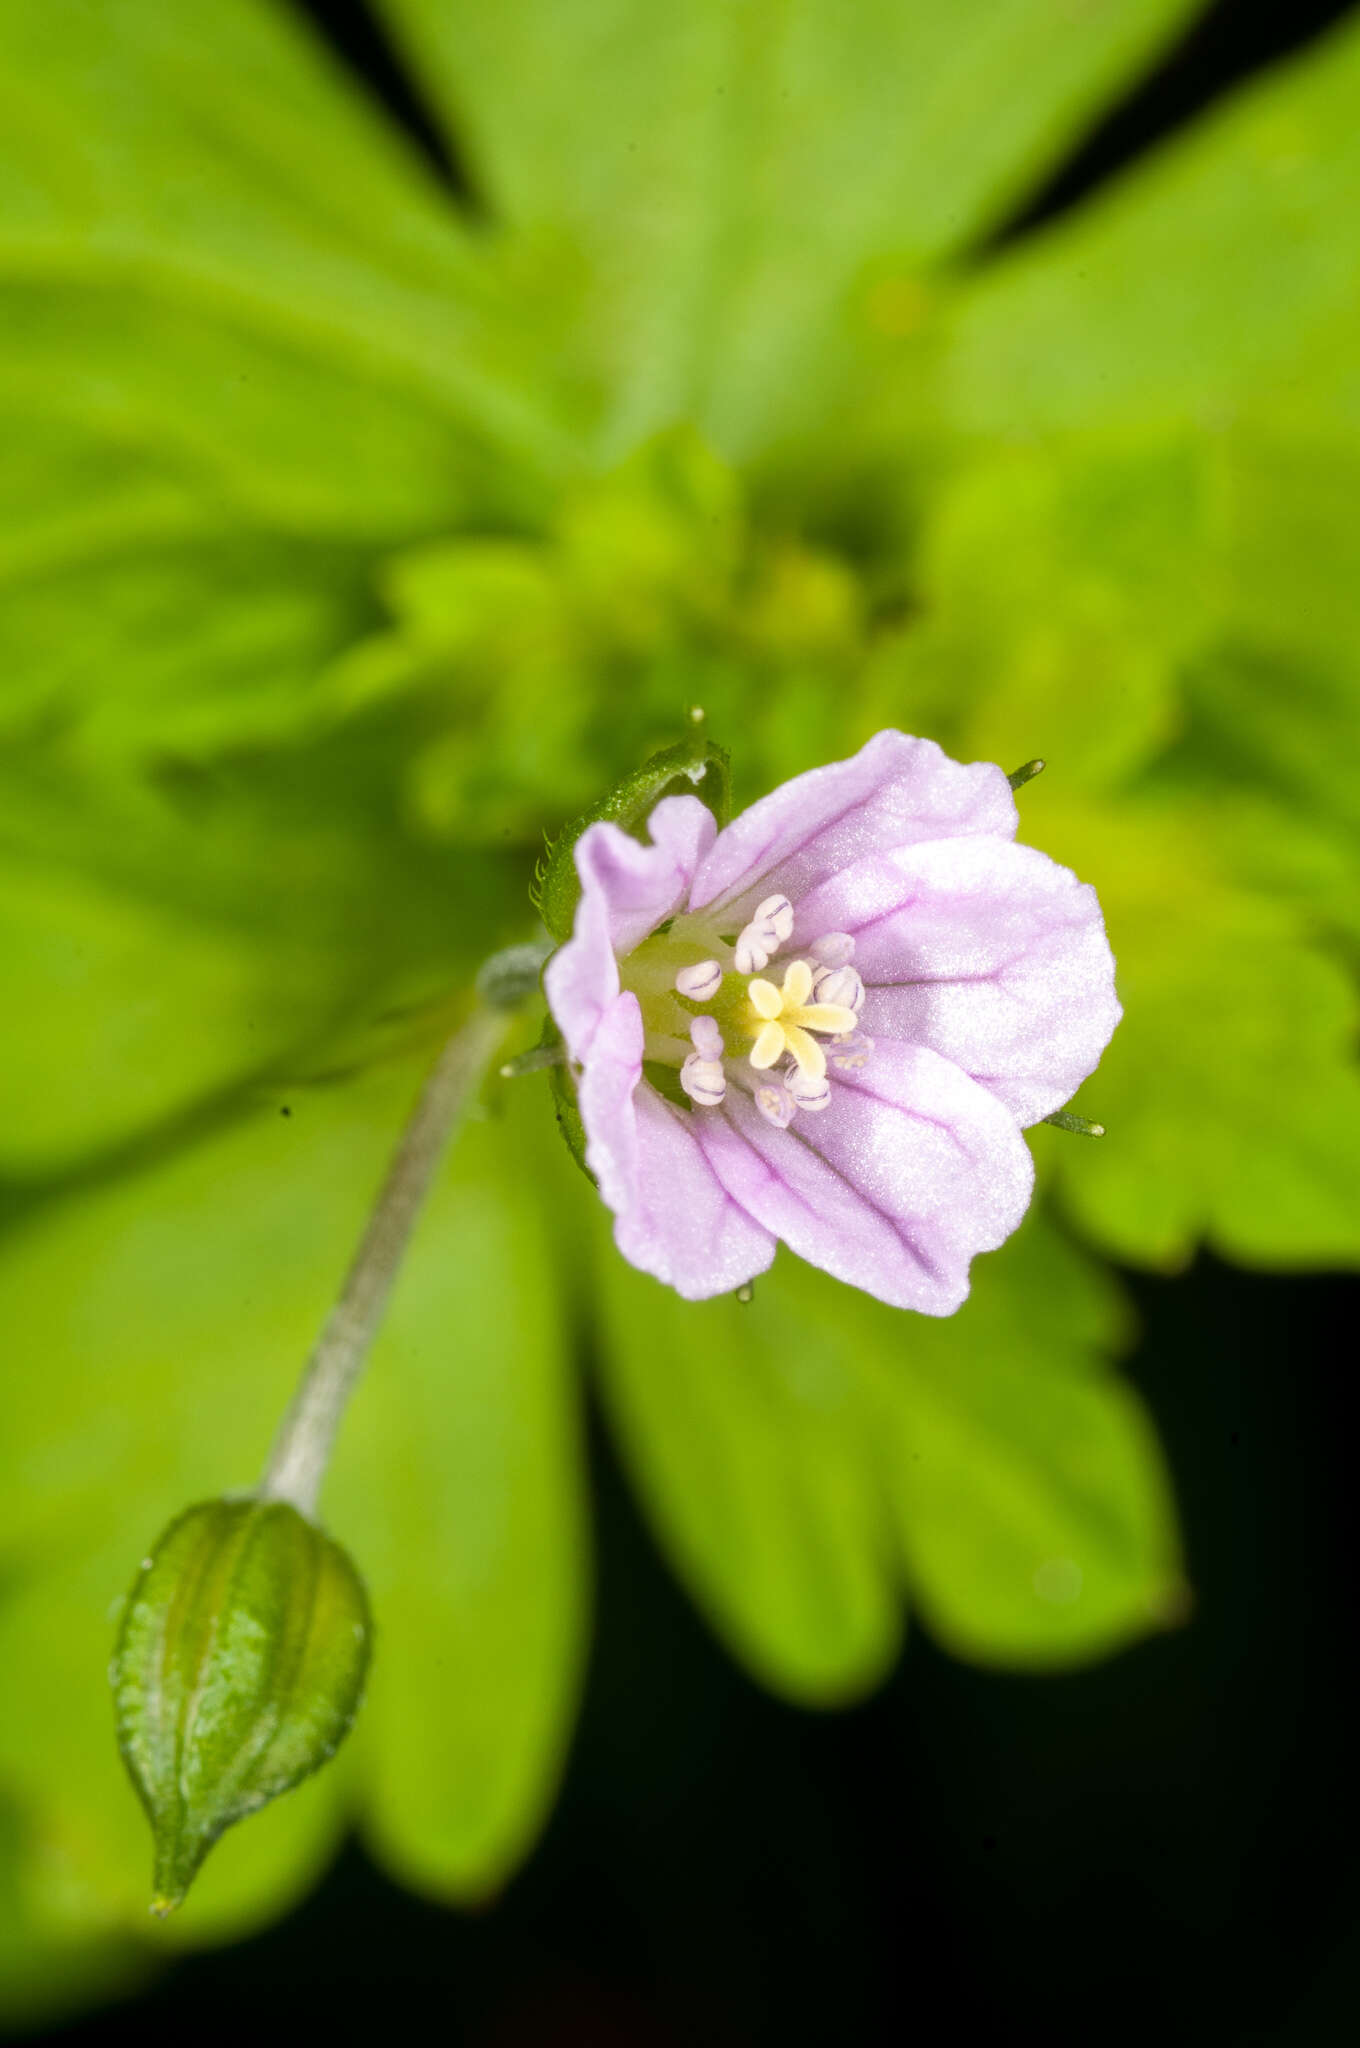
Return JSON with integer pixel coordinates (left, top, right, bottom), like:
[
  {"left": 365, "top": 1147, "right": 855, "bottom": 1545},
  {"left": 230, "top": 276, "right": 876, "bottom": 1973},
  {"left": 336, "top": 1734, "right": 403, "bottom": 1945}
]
[{"left": 1026, "top": 784, "right": 1360, "bottom": 1270}]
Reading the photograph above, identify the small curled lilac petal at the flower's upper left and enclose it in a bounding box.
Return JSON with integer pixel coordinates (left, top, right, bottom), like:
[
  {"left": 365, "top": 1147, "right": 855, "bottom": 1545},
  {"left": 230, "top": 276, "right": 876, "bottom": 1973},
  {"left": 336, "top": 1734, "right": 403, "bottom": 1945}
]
[{"left": 543, "top": 797, "right": 717, "bottom": 1059}]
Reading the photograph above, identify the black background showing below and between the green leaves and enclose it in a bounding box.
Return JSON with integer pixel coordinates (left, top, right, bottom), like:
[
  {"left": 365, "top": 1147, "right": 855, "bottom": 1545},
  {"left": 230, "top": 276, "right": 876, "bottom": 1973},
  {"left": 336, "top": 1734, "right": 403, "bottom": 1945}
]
[{"left": 23, "top": 0, "right": 1360, "bottom": 2048}]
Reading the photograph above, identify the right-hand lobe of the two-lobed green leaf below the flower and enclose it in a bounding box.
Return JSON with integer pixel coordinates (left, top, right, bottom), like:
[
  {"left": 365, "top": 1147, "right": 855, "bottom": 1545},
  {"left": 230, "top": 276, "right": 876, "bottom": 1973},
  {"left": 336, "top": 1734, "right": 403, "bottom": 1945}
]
[{"left": 780, "top": 1212, "right": 1186, "bottom": 1669}]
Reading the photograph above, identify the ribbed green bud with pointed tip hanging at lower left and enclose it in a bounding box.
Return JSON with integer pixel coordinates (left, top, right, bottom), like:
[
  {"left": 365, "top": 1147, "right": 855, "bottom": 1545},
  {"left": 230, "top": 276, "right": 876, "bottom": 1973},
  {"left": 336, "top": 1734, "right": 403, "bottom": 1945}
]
[{"left": 109, "top": 1499, "right": 373, "bottom": 1915}]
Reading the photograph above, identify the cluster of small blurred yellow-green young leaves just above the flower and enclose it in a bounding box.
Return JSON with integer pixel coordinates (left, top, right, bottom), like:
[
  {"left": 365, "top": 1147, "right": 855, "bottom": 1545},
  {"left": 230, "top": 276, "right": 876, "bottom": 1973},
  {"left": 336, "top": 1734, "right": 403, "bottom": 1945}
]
[{"left": 320, "top": 428, "right": 868, "bottom": 848}]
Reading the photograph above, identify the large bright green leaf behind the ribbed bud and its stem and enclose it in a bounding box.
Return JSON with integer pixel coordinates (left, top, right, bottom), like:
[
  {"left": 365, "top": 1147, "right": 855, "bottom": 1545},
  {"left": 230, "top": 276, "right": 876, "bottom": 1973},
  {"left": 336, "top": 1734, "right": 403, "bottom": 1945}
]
[{"left": 0, "top": 1065, "right": 584, "bottom": 1946}]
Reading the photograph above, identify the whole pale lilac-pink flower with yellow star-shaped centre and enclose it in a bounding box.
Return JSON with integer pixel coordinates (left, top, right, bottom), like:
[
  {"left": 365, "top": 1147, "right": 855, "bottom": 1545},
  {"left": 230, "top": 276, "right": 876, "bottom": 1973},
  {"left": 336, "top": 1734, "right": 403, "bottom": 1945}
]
[{"left": 545, "top": 731, "right": 1120, "bottom": 1315}]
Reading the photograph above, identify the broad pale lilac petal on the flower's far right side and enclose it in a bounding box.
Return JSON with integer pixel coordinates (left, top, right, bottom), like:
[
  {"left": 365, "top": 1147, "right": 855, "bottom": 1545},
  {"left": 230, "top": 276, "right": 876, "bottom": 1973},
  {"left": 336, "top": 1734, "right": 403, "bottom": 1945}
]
[{"left": 801, "top": 840, "right": 1120, "bottom": 1124}]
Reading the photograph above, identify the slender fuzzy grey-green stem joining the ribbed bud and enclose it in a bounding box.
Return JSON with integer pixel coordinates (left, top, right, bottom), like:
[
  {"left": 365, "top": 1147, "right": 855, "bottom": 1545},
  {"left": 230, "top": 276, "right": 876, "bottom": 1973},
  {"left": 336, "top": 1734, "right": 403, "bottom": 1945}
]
[{"left": 260, "top": 1006, "right": 510, "bottom": 1516}]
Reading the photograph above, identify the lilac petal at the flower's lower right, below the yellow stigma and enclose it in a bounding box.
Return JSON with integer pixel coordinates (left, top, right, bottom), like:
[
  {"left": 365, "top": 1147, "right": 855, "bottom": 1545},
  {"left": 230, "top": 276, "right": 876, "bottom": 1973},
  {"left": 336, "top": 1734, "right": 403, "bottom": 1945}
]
[{"left": 696, "top": 1044, "right": 1034, "bottom": 1315}]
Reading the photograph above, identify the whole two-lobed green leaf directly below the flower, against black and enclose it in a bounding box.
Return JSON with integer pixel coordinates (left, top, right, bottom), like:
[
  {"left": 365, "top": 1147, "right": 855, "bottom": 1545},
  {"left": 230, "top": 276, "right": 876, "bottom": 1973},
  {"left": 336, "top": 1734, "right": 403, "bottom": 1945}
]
[{"left": 600, "top": 1217, "right": 1186, "bottom": 1679}]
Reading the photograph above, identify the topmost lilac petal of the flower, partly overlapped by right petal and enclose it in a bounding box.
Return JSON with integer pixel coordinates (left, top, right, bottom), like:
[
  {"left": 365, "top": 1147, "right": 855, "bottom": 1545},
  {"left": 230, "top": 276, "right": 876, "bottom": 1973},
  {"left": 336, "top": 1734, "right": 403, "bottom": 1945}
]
[{"left": 690, "top": 731, "right": 1016, "bottom": 940}]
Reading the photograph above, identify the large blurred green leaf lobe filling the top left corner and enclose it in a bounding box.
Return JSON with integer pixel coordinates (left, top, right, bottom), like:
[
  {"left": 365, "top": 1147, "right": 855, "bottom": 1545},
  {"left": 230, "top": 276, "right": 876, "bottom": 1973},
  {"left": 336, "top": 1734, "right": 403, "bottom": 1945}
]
[{"left": 0, "top": 0, "right": 571, "bottom": 770}]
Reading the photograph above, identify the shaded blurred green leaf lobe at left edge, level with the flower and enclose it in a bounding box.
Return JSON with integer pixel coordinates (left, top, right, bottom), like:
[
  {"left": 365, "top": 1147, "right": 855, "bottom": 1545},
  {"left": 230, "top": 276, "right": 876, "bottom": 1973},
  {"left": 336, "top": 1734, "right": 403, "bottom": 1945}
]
[{"left": 0, "top": 745, "right": 528, "bottom": 1180}]
